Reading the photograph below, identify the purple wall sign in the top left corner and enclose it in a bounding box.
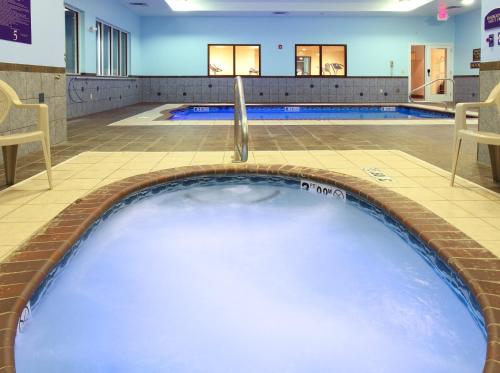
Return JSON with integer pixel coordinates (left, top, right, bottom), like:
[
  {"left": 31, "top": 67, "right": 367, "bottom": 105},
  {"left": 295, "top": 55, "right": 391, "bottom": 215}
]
[{"left": 0, "top": 0, "right": 31, "bottom": 44}]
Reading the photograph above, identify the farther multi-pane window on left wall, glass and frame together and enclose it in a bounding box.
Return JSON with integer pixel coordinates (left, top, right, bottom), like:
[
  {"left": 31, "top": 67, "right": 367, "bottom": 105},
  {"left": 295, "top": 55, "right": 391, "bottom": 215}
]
[{"left": 96, "top": 21, "right": 128, "bottom": 76}]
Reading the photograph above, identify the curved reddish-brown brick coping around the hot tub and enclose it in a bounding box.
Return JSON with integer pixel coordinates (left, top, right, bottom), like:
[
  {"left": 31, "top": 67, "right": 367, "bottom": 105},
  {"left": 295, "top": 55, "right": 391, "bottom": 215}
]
[{"left": 0, "top": 164, "right": 500, "bottom": 373}]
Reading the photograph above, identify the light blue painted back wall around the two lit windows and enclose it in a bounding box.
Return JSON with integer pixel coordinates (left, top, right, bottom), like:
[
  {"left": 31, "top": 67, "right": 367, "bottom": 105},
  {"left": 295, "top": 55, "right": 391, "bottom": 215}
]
[{"left": 141, "top": 17, "right": 455, "bottom": 76}]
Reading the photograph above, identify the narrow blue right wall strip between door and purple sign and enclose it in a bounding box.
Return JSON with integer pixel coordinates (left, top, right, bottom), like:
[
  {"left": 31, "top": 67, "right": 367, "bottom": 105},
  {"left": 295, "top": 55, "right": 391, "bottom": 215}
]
[{"left": 453, "top": 9, "right": 481, "bottom": 75}]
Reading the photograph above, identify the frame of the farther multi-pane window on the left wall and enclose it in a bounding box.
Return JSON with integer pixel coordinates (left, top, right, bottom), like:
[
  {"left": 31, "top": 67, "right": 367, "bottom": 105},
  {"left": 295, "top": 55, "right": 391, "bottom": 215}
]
[{"left": 96, "top": 19, "right": 130, "bottom": 78}]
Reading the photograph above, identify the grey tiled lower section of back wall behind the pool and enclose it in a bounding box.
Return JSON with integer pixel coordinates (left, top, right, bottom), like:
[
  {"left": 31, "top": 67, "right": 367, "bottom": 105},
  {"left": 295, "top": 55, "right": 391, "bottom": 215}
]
[{"left": 142, "top": 77, "right": 408, "bottom": 104}]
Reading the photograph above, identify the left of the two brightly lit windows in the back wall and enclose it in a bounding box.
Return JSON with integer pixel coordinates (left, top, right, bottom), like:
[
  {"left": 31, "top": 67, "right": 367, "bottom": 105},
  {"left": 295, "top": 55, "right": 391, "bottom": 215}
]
[{"left": 208, "top": 44, "right": 260, "bottom": 76}]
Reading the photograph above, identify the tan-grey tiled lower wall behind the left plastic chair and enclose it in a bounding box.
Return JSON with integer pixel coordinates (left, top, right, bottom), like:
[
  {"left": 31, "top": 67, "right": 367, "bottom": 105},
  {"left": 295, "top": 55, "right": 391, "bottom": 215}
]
[{"left": 0, "top": 66, "right": 67, "bottom": 164}]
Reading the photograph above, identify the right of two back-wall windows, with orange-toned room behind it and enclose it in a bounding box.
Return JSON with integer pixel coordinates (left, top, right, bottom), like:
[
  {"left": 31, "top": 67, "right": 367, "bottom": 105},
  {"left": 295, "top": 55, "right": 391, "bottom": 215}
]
[{"left": 295, "top": 45, "right": 347, "bottom": 76}]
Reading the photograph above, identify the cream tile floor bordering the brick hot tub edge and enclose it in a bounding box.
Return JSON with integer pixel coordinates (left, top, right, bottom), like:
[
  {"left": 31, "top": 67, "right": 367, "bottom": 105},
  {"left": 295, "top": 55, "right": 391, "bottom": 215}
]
[{"left": 0, "top": 149, "right": 500, "bottom": 261}]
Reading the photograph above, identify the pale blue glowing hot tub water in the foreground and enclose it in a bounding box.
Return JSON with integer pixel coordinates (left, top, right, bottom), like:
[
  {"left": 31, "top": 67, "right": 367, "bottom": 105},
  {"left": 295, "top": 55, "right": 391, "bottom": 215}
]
[{"left": 15, "top": 176, "right": 486, "bottom": 373}]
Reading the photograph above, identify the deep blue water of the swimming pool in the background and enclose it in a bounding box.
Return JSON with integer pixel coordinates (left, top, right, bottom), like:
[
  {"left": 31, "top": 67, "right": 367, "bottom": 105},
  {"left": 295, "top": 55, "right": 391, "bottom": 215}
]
[{"left": 170, "top": 106, "right": 453, "bottom": 120}]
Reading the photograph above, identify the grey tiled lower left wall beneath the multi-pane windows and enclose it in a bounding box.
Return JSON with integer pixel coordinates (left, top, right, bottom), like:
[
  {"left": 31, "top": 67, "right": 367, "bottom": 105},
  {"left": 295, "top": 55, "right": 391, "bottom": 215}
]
[{"left": 67, "top": 76, "right": 142, "bottom": 118}]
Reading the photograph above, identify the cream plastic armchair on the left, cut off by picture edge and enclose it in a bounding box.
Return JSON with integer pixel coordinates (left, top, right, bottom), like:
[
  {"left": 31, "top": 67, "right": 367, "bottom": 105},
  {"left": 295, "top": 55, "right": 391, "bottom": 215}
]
[{"left": 0, "top": 80, "right": 52, "bottom": 189}]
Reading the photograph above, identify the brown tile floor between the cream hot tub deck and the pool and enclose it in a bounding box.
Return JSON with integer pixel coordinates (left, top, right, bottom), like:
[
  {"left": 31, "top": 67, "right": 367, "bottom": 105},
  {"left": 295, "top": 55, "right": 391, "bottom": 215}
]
[{"left": 0, "top": 104, "right": 500, "bottom": 192}]
